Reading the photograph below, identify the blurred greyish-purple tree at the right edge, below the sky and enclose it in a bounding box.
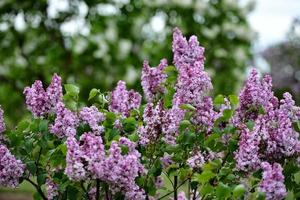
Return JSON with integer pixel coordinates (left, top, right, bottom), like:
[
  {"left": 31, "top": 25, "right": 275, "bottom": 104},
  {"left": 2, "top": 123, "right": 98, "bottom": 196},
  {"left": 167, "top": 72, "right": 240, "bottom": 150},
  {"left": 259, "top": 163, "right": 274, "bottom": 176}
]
[{"left": 262, "top": 18, "right": 300, "bottom": 102}]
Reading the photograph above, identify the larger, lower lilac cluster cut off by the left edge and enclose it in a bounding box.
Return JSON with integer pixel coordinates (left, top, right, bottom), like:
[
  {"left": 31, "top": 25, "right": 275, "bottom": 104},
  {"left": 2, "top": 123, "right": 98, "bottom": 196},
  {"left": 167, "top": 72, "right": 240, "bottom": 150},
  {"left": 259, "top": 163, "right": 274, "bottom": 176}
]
[{"left": 0, "top": 144, "right": 25, "bottom": 188}]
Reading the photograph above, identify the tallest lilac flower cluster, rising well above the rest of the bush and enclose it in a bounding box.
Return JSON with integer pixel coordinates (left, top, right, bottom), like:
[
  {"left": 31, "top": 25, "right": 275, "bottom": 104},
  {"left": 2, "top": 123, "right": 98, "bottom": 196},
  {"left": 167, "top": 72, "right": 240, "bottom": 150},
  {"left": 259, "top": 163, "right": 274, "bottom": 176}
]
[{"left": 163, "top": 28, "right": 217, "bottom": 144}]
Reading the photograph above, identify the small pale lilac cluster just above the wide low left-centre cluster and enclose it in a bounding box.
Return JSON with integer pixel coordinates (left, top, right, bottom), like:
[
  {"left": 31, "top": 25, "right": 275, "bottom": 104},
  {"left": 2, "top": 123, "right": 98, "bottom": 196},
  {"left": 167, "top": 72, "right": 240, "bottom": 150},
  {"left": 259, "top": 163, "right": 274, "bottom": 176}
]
[{"left": 79, "top": 106, "right": 105, "bottom": 133}]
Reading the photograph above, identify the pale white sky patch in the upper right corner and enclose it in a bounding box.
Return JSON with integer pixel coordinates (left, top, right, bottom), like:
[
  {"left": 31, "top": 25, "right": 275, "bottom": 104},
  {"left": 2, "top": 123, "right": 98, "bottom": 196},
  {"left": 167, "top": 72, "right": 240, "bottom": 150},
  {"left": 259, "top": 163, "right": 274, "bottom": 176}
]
[{"left": 246, "top": 0, "right": 300, "bottom": 50}]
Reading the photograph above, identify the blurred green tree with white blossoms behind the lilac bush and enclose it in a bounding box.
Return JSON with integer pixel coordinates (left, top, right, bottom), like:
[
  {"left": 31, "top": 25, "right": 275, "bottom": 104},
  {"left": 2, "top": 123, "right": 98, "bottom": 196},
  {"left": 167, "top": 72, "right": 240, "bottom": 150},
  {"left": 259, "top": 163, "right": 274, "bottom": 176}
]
[{"left": 0, "top": 0, "right": 254, "bottom": 125}]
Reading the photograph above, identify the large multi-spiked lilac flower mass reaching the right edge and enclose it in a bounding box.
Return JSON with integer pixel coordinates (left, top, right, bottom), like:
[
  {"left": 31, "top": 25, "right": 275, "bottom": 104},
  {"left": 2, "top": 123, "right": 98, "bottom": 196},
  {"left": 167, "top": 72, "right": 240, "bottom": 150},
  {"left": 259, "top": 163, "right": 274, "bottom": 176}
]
[{"left": 233, "top": 70, "right": 300, "bottom": 171}]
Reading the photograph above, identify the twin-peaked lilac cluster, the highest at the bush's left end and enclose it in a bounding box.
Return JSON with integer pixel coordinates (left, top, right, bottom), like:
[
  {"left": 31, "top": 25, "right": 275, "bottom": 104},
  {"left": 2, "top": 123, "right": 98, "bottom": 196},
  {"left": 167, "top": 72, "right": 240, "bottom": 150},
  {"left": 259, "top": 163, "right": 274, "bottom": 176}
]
[{"left": 23, "top": 74, "right": 62, "bottom": 117}]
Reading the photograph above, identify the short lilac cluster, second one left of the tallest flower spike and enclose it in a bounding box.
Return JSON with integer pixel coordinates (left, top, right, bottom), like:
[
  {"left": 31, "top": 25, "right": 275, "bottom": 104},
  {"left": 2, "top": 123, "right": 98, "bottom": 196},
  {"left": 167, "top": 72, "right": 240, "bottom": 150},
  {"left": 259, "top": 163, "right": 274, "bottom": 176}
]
[{"left": 109, "top": 81, "right": 142, "bottom": 117}]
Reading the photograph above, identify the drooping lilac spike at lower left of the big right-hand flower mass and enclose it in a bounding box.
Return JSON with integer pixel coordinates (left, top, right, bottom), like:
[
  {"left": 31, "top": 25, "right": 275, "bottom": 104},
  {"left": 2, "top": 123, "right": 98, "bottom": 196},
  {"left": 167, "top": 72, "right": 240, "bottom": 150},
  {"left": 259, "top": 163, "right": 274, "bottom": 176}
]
[{"left": 235, "top": 126, "right": 261, "bottom": 171}]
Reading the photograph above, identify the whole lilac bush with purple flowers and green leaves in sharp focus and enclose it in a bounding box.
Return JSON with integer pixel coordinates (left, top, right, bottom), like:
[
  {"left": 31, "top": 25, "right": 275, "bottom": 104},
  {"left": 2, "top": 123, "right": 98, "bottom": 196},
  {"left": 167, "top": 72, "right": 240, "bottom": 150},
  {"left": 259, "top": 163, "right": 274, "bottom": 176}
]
[{"left": 0, "top": 28, "right": 300, "bottom": 200}]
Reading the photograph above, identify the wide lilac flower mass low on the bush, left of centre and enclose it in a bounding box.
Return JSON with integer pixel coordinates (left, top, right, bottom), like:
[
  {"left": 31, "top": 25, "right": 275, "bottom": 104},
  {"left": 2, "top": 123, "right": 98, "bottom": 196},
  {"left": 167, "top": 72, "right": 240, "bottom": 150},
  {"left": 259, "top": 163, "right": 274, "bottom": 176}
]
[{"left": 65, "top": 133, "right": 144, "bottom": 200}]
